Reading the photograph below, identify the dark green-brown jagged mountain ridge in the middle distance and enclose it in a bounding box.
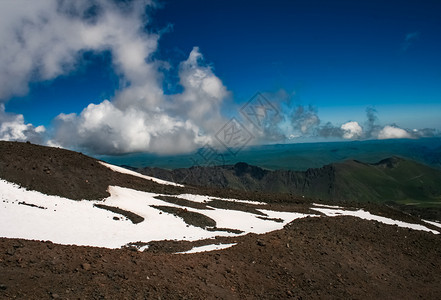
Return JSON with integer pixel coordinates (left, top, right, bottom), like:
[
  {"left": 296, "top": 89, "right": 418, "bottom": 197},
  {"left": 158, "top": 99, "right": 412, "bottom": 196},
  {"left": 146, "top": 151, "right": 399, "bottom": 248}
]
[{"left": 136, "top": 156, "right": 441, "bottom": 206}]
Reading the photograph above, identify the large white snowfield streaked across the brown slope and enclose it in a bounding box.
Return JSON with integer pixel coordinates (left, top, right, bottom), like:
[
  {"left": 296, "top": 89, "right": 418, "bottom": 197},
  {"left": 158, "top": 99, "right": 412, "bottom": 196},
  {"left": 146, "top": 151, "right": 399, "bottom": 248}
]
[{"left": 0, "top": 180, "right": 439, "bottom": 251}]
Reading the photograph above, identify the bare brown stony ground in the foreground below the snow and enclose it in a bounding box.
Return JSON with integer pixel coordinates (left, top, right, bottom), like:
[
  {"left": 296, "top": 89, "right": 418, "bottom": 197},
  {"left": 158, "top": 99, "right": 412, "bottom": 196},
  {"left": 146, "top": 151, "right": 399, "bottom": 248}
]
[{"left": 0, "top": 217, "right": 441, "bottom": 299}]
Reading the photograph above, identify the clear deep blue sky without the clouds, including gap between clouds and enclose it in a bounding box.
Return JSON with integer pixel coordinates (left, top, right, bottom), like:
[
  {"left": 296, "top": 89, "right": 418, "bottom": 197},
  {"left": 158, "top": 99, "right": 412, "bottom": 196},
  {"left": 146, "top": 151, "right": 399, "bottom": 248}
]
[{"left": 6, "top": 0, "right": 441, "bottom": 129}]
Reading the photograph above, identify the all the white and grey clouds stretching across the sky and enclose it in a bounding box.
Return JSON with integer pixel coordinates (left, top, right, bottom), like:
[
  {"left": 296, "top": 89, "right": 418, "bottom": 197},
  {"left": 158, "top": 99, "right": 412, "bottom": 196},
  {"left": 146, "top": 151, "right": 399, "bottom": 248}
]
[{"left": 0, "top": 0, "right": 437, "bottom": 154}]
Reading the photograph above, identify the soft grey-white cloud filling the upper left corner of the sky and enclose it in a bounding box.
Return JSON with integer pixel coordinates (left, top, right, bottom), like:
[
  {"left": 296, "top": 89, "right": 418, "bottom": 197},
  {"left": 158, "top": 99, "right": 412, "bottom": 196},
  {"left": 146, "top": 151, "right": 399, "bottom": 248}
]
[{"left": 0, "top": 0, "right": 158, "bottom": 100}]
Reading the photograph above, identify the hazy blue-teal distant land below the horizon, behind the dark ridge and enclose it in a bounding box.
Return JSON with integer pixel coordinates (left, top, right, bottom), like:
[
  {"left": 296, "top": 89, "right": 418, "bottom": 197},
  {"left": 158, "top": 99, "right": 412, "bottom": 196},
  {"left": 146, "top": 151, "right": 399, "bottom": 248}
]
[{"left": 97, "top": 137, "right": 441, "bottom": 171}]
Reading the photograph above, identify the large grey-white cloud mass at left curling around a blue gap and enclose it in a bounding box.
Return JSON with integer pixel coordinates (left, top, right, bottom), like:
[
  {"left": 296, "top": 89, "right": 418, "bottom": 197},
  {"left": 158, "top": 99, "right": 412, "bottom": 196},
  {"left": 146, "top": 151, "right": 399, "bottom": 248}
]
[{"left": 0, "top": 0, "right": 228, "bottom": 153}]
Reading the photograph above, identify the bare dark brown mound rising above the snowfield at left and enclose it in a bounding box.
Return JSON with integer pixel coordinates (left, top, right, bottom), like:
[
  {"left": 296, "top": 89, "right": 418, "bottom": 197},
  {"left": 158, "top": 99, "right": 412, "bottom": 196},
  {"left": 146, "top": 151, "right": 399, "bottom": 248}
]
[{"left": 0, "top": 141, "right": 187, "bottom": 200}]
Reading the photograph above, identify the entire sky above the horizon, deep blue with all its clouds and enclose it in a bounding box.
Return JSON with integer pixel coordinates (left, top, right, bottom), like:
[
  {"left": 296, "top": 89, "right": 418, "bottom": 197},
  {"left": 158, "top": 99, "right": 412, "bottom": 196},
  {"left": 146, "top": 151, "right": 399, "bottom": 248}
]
[{"left": 0, "top": 0, "right": 441, "bottom": 154}]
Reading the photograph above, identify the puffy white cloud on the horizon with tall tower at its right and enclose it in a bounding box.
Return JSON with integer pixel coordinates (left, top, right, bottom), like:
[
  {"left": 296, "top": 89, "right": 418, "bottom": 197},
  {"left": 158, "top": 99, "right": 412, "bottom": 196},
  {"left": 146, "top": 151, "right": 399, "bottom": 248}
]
[{"left": 53, "top": 48, "right": 228, "bottom": 154}]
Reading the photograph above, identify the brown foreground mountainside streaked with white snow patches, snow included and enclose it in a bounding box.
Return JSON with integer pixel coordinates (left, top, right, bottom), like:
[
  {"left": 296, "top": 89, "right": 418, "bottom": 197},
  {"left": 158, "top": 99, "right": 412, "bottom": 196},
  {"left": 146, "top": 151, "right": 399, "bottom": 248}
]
[{"left": 0, "top": 142, "right": 441, "bottom": 299}]
